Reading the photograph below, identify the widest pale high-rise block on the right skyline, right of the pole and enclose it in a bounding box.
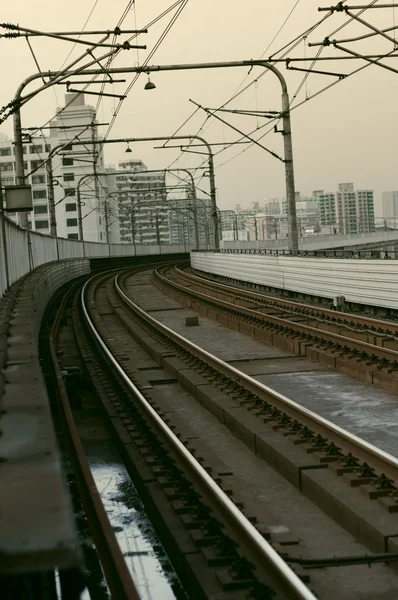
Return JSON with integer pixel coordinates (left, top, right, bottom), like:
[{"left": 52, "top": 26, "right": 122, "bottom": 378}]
[{"left": 313, "top": 183, "right": 375, "bottom": 234}]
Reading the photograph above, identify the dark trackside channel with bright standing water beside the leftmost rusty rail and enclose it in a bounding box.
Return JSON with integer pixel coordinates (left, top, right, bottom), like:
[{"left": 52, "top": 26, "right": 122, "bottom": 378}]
[{"left": 42, "top": 282, "right": 187, "bottom": 600}]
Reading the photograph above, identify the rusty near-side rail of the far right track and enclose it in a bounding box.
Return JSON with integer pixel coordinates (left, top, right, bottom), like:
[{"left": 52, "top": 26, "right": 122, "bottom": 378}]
[{"left": 157, "top": 271, "right": 398, "bottom": 362}]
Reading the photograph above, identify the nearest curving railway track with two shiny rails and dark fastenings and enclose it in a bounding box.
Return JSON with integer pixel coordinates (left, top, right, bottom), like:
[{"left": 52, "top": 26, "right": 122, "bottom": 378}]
[{"left": 47, "top": 268, "right": 398, "bottom": 600}]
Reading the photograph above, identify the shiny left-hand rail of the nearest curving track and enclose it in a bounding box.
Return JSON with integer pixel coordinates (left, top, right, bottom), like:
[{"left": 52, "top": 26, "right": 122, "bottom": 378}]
[{"left": 81, "top": 277, "right": 316, "bottom": 600}]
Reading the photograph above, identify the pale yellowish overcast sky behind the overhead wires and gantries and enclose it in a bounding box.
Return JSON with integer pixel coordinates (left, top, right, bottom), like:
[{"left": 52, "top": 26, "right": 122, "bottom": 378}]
[{"left": 0, "top": 0, "right": 398, "bottom": 216}]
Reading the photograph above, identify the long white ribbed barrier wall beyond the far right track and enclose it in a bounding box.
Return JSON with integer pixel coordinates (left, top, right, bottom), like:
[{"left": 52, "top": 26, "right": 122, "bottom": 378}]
[{"left": 191, "top": 252, "right": 398, "bottom": 309}]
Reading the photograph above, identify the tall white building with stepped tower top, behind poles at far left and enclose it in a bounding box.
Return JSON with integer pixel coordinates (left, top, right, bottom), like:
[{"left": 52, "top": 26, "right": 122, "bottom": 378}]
[{"left": 0, "top": 94, "right": 110, "bottom": 242}]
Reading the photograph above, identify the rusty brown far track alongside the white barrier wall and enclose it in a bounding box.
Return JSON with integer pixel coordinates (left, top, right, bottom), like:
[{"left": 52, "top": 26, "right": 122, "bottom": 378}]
[{"left": 156, "top": 267, "right": 398, "bottom": 392}]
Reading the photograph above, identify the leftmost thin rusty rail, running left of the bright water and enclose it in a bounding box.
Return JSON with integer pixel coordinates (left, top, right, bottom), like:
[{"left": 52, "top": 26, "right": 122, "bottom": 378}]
[{"left": 50, "top": 286, "right": 140, "bottom": 600}]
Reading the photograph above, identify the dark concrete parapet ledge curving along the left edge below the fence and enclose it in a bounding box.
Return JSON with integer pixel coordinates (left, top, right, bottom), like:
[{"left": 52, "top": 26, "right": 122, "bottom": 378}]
[{"left": 0, "top": 259, "right": 90, "bottom": 574}]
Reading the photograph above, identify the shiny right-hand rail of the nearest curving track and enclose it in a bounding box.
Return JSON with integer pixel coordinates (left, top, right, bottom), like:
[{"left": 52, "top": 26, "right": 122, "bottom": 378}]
[{"left": 115, "top": 270, "right": 398, "bottom": 483}]
